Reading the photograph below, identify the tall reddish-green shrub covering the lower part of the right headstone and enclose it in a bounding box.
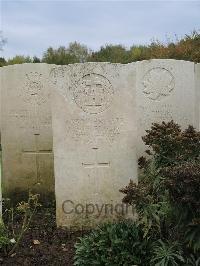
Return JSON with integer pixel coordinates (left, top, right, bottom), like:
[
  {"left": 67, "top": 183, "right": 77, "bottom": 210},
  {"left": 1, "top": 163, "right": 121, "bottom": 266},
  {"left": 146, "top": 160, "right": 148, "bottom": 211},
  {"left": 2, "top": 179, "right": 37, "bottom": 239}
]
[{"left": 120, "top": 121, "right": 200, "bottom": 265}]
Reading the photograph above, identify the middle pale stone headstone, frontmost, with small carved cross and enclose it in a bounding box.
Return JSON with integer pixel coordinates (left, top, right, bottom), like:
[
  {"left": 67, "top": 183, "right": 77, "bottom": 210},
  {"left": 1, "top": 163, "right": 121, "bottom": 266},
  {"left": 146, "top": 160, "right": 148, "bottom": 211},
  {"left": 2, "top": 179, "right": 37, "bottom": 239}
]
[{"left": 51, "top": 63, "right": 137, "bottom": 227}]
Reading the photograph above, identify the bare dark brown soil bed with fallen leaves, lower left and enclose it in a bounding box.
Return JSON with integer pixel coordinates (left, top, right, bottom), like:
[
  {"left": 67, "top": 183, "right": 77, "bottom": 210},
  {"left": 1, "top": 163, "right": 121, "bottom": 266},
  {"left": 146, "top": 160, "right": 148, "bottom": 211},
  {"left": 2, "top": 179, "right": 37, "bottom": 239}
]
[{"left": 0, "top": 204, "right": 83, "bottom": 266}]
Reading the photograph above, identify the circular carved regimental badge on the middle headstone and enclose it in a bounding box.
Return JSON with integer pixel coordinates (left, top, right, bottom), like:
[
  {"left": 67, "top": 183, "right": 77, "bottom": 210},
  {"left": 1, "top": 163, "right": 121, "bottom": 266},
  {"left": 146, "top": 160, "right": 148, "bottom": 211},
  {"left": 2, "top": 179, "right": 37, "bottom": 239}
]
[{"left": 74, "top": 73, "right": 114, "bottom": 114}]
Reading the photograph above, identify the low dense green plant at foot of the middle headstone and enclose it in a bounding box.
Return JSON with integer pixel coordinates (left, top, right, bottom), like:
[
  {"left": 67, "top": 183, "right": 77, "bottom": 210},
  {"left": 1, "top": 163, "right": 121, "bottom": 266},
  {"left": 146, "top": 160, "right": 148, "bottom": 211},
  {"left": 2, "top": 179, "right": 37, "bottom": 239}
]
[{"left": 74, "top": 221, "right": 150, "bottom": 266}]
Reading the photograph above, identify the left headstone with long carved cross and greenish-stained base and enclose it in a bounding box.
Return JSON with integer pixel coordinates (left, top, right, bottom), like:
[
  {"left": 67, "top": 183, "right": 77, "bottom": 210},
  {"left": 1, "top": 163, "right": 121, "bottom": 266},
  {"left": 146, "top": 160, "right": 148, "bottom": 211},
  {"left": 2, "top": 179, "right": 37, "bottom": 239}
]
[{"left": 1, "top": 64, "right": 54, "bottom": 197}]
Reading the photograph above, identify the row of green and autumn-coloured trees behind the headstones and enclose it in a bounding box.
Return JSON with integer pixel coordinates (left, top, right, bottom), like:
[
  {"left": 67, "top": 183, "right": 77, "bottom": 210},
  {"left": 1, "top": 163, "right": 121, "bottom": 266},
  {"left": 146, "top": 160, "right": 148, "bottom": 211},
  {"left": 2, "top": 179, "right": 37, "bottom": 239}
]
[{"left": 3, "top": 31, "right": 200, "bottom": 66}]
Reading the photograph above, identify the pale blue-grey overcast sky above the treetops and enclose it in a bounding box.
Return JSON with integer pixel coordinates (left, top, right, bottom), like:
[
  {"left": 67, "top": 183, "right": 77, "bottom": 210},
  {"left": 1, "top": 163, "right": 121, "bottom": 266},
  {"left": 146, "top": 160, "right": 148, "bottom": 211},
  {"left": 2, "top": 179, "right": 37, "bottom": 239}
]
[{"left": 0, "top": 0, "right": 200, "bottom": 58}]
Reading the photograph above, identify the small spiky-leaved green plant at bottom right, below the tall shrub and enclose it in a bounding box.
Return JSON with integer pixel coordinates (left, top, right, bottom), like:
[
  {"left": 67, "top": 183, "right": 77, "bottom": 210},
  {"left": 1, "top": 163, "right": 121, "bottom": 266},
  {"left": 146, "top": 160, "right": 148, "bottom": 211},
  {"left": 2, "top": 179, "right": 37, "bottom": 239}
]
[{"left": 151, "top": 240, "right": 184, "bottom": 266}]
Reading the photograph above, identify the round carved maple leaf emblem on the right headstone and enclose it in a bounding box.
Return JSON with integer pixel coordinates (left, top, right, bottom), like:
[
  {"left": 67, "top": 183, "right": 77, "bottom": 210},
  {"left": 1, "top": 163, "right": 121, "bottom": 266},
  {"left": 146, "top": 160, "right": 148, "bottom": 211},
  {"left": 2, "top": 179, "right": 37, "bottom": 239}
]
[{"left": 142, "top": 67, "right": 175, "bottom": 100}]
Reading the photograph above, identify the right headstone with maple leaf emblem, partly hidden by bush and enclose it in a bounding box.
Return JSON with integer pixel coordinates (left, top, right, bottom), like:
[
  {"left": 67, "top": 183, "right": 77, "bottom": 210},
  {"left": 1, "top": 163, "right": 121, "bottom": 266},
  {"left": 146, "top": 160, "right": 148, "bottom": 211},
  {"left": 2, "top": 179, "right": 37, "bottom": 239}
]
[{"left": 136, "top": 59, "right": 198, "bottom": 156}]
